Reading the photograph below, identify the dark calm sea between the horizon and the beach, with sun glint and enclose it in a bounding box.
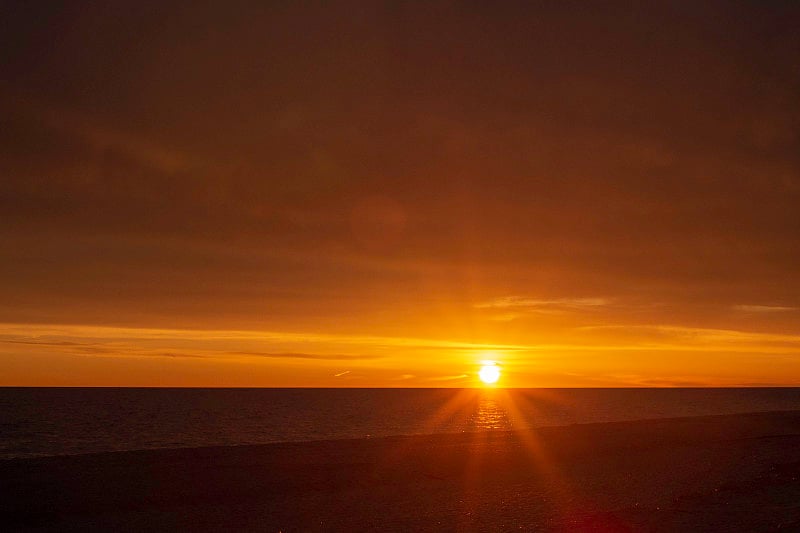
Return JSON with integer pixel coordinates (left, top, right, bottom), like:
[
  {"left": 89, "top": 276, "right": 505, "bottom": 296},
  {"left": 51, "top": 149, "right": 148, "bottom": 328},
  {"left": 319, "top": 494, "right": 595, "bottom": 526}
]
[{"left": 0, "top": 388, "right": 800, "bottom": 459}]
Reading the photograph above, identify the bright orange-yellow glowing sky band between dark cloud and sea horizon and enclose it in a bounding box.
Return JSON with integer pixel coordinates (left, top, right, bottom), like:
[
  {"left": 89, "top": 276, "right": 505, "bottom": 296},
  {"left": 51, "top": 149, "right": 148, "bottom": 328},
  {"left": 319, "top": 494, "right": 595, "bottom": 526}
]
[{"left": 0, "top": 324, "right": 800, "bottom": 387}]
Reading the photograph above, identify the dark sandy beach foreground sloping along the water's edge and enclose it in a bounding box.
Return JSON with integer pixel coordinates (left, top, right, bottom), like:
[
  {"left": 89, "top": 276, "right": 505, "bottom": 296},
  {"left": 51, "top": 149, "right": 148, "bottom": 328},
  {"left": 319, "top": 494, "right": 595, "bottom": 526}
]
[{"left": 0, "top": 411, "right": 800, "bottom": 531}]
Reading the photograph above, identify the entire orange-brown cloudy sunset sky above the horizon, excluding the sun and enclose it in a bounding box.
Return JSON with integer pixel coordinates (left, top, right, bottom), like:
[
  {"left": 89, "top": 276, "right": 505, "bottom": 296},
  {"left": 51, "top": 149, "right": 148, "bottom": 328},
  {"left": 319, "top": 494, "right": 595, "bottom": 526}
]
[{"left": 0, "top": 0, "right": 800, "bottom": 387}]
